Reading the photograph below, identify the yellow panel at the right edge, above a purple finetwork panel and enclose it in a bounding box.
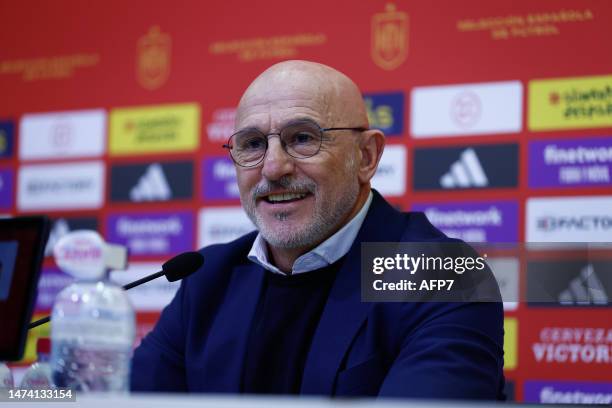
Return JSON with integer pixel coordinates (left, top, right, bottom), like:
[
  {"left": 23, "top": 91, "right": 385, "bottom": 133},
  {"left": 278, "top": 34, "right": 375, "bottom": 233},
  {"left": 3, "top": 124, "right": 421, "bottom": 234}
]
[{"left": 529, "top": 75, "right": 612, "bottom": 131}]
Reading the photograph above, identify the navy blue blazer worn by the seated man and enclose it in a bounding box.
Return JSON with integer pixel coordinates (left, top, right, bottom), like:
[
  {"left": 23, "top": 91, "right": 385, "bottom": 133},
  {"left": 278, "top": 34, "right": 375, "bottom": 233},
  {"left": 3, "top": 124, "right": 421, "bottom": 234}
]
[{"left": 131, "top": 192, "right": 504, "bottom": 399}]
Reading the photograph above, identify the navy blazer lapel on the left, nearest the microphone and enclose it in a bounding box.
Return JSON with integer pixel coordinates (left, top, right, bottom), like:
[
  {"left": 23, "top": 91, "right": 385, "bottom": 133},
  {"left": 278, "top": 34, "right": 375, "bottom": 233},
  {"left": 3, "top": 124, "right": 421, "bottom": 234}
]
[{"left": 197, "top": 264, "right": 264, "bottom": 393}]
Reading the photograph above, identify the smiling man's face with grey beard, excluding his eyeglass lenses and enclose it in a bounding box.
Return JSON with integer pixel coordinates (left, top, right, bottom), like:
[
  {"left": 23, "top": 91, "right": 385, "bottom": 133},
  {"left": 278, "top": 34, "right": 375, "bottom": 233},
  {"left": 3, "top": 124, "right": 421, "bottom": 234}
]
[{"left": 236, "top": 86, "right": 359, "bottom": 249}]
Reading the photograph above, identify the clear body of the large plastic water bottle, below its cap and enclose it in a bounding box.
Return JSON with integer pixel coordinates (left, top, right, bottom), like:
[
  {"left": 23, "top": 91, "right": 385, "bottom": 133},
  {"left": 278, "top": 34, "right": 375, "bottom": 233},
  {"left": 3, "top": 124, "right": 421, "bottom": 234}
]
[{"left": 51, "top": 279, "right": 135, "bottom": 392}]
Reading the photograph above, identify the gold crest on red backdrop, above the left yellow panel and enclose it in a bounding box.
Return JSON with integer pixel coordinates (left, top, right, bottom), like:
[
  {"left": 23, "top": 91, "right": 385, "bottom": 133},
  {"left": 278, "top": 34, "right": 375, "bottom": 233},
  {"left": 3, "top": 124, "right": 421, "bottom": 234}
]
[{"left": 136, "top": 26, "right": 172, "bottom": 90}]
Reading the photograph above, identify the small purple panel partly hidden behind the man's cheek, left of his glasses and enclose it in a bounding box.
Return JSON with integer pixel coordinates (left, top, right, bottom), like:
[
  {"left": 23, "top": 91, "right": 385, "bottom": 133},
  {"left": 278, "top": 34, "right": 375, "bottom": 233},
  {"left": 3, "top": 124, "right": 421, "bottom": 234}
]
[{"left": 202, "top": 157, "right": 240, "bottom": 200}]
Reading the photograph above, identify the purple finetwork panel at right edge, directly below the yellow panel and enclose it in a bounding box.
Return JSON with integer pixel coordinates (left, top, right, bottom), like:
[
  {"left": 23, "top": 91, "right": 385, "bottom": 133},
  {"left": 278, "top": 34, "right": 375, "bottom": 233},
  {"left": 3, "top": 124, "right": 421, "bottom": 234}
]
[{"left": 529, "top": 137, "right": 612, "bottom": 188}]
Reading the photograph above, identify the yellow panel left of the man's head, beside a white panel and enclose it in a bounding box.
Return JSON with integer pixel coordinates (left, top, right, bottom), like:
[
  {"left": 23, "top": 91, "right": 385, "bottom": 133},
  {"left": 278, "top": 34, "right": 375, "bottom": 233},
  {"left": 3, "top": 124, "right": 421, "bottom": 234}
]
[{"left": 109, "top": 103, "right": 200, "bottom": 156}]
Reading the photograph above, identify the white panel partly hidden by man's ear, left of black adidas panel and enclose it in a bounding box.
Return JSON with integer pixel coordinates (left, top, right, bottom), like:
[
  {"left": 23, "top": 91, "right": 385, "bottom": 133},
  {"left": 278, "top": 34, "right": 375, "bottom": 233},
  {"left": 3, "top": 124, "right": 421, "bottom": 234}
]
[{"left": 372, "top": 145, "right": 406, "bottom": 196}]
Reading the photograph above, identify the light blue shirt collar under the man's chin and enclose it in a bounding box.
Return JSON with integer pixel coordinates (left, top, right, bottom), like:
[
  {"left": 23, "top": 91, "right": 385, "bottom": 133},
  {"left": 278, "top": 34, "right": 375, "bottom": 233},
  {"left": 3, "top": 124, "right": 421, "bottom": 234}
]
[{"left": 247, "top": 191, "right": 372, "bottom": 275}]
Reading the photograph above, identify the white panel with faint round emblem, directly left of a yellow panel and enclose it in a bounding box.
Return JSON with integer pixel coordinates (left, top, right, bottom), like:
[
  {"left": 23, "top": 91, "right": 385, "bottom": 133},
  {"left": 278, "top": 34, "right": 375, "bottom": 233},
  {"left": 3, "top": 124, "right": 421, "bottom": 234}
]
[{"left": 19, "top": 109, "right": 106, "bottom": 160}]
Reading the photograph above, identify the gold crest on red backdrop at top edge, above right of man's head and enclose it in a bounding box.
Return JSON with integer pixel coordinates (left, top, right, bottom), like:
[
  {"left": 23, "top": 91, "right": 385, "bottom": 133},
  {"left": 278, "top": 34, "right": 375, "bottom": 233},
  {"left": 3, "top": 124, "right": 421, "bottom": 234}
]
[{"left": 371, "top": 3, "right": 408, "bottom": 71}]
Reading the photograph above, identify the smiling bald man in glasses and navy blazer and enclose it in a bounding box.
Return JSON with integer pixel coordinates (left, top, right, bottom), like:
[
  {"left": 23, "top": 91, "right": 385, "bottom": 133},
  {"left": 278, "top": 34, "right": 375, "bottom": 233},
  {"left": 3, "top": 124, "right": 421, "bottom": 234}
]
[{"left": 132, "top": 61, "right": 504, "bottom": 399}]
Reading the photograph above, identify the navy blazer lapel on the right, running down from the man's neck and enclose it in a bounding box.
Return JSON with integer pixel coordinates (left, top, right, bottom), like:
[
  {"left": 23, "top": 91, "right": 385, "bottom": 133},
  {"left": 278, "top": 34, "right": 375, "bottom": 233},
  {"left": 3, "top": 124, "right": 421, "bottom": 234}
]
[{"left": 301, "top": 190, "right": 406, "bottom": 395}]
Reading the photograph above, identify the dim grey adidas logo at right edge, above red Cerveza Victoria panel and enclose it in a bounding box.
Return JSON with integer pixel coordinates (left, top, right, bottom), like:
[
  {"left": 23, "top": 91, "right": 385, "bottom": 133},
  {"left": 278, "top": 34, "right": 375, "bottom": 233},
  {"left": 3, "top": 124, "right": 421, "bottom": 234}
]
[{"left": 559, "top": 264, "right": 608, "bottom": 305}]
